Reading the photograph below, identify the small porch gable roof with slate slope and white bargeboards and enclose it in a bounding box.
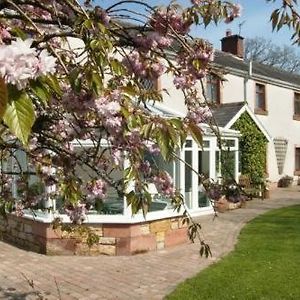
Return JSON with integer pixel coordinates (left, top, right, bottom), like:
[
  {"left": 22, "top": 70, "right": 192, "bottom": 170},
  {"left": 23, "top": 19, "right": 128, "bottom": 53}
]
[{"left": 213, "top": 102, "right": 272, "bottom": 142}]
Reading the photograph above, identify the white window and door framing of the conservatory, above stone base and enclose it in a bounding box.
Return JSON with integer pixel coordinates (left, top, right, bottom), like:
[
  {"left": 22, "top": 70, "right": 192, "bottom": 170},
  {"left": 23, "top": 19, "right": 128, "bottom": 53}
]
[{"left": 24, "top": 125, "right": 240, "bottom": 224}]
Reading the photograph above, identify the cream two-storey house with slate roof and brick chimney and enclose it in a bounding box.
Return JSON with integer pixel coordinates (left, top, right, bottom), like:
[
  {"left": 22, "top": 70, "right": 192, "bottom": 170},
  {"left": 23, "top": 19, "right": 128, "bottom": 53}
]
[{"left": 202, "top": 31, "right": 300, "bottom": 182}]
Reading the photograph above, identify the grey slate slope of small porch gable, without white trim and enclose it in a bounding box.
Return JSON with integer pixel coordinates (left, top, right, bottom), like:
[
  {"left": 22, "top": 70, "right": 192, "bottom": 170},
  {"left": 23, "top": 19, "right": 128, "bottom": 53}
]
[{"left": 213, "top": 102, "right": 245, "bottom": 127}]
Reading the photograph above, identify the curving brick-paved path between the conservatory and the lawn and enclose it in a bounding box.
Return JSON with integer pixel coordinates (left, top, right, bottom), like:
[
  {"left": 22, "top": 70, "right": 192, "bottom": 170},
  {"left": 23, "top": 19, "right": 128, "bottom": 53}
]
[{"left": 0, "top": 187, "right": 300, "bottom": 300}]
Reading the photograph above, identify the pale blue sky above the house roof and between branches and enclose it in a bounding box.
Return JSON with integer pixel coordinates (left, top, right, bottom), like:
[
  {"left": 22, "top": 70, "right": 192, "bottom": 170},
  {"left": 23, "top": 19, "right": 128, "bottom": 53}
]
[{"left": 94, "top": 0, "right": 300, "bottom": 54}]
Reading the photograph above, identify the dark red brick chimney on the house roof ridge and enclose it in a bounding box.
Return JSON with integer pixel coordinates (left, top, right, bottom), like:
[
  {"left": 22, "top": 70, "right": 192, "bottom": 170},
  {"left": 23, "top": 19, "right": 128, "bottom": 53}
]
[{"left": 221, "top": 29, "right": 244, "bottom": 58}]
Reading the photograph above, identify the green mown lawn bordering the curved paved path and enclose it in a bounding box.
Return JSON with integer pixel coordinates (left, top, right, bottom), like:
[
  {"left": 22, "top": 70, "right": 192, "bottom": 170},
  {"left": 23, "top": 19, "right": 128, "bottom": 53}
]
[{"left": 166, "top": 205, "right": 300, "bottom": 300}]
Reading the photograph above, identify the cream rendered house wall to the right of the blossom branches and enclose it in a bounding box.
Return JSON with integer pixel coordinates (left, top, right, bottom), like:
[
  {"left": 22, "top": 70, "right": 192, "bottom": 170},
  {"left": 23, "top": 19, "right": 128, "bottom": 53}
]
[{"left": 222, "top": 74, "right": 300, "bottom": 182}]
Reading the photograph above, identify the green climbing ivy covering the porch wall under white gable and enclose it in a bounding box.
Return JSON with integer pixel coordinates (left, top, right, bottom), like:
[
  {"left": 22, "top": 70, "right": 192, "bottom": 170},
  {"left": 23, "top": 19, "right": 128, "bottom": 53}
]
[{"left": 232, "top": 112, "right": 267, "bottom": 184}]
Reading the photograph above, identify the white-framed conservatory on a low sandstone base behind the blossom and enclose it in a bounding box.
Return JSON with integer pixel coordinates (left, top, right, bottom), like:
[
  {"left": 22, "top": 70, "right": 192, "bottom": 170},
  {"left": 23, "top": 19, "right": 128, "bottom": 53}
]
[{"left": 0, "top": 125, "right": 240, "bottom": 255}]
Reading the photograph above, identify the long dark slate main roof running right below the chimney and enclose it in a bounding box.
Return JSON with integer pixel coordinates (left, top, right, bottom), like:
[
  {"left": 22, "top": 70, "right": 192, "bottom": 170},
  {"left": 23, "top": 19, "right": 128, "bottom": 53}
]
[{"left": 214, "top": 51, "right": 300, "bottom": 88}]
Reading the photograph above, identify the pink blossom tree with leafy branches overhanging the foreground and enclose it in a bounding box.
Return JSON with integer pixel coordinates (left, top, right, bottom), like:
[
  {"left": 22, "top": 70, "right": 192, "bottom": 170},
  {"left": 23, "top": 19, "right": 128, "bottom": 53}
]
[{"left": 0, "top": 0, "right": 292, "bottom": 253}]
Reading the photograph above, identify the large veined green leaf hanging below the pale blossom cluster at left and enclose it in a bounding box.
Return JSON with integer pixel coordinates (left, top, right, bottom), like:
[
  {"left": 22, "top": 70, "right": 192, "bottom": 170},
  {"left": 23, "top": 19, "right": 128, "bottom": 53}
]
[{"left": 3, "top": 92, "right": 35, "bottom": 145}]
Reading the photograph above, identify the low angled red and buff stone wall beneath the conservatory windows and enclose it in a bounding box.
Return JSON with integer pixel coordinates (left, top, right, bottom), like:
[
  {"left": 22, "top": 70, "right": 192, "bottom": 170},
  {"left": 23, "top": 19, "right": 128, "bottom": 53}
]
[{"left": 0, "top": 215, "right": 188, "bottom": 255}]
